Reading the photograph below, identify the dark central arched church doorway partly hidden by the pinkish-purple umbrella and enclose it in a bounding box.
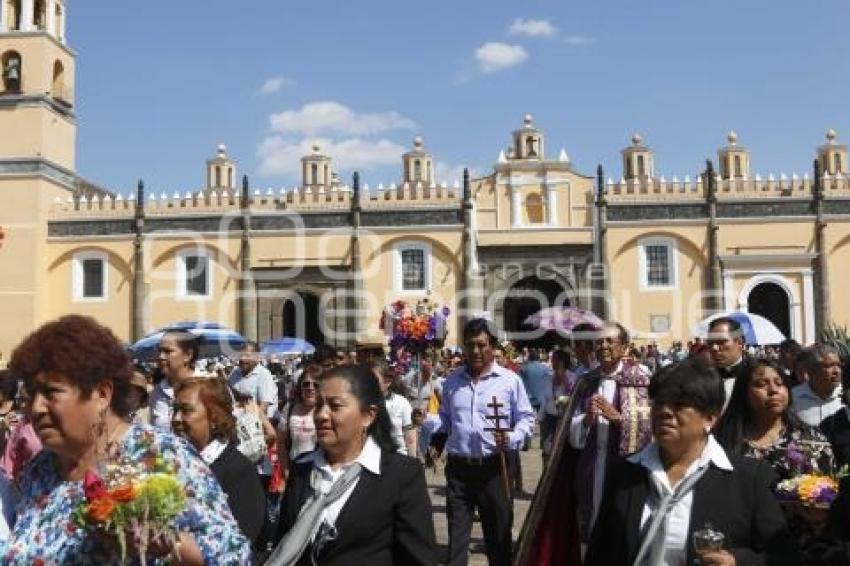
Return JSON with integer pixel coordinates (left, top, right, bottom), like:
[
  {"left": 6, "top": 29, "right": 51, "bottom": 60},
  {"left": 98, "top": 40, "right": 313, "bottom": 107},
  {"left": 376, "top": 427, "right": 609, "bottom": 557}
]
[{"left": 503, "top": 276, "right": 570, "bottom": 348}]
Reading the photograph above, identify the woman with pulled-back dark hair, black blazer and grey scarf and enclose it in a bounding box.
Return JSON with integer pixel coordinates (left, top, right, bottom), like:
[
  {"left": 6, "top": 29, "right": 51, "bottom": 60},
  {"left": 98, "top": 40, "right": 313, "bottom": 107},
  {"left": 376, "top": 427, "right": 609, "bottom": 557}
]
[{"left": 267, "top": 365, "right": 437, "bottom": 566}]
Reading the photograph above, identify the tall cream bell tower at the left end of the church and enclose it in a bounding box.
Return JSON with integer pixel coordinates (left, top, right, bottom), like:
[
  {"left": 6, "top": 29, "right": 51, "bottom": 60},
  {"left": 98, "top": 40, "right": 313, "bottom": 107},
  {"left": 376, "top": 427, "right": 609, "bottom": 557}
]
[{"left": 0, "top": 0, "right": 78, "bottom": 360}]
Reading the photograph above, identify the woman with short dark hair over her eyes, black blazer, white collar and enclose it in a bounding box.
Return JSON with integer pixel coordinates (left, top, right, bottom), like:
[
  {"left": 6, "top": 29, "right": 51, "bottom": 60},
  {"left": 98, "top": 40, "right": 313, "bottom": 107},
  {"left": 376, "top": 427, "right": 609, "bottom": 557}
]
[{"left": 585, "top": 358, "right": 800, "bottom": 566}]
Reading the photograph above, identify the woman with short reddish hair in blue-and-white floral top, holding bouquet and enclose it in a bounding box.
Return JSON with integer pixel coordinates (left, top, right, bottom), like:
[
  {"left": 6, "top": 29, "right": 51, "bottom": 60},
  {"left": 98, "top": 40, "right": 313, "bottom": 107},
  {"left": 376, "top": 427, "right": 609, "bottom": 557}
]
[{"left": 0, "top": 315, "right": 251, "bottom": 565}]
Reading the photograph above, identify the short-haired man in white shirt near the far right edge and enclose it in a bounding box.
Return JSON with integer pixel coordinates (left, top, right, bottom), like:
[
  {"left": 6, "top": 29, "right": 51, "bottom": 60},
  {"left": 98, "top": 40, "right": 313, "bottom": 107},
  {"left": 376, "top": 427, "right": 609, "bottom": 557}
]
[{"left": 791, "top": 344, "right": 841, "bottom": 427}]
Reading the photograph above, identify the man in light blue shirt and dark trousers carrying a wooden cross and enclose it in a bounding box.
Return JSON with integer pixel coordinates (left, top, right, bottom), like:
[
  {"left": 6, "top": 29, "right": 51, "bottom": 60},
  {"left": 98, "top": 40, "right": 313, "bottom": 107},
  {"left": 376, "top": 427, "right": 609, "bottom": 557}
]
[{"left": 437, "top": 319, "right": 534, "bottom": 566}]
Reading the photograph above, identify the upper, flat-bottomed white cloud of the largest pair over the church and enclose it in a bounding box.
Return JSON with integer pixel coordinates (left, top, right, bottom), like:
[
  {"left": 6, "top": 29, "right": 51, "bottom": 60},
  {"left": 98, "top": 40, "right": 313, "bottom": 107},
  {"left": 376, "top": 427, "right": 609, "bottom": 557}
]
[{"left": 269, "top": 101, "right": 416, "bottom": 136}]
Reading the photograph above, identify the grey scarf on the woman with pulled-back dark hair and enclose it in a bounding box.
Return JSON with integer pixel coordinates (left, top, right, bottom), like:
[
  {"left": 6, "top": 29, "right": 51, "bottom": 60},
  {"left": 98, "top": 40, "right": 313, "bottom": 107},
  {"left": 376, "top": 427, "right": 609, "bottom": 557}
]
[{"left": 266, "top": 462, "right": 362, "bottom": 566}]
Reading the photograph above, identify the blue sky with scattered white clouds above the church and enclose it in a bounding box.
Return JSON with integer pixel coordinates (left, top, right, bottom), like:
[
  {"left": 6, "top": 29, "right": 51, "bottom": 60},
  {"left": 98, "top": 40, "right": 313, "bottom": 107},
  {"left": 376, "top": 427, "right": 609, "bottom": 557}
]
[{"left": 68, "top": 0, "right": 850, "bottom": 195}]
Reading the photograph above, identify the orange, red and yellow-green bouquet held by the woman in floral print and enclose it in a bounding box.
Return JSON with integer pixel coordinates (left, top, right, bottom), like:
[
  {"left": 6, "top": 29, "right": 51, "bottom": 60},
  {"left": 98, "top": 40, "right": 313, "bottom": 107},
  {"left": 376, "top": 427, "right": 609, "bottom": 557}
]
[{"left": 74, "top": 455, "right": 186, "bottom": 566}]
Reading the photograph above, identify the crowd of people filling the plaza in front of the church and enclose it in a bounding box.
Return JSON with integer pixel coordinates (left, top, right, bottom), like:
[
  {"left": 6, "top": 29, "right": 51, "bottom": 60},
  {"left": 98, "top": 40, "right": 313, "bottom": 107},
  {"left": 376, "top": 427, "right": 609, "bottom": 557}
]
[{"left": 0, "top": 316, "right": 850, "bottom": 566}]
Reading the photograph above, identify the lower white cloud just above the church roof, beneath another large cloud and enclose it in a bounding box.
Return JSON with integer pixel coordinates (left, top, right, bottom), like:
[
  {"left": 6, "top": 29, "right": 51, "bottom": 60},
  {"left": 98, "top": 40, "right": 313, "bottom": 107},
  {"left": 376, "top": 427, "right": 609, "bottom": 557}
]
[{"left": 257, "top": 135, "right": 406, "bottom": 176}]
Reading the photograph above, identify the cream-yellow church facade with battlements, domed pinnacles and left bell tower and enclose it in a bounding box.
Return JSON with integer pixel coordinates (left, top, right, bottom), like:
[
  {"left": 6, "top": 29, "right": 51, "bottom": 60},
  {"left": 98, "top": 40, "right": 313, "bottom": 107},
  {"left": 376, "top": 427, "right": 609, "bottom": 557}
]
[{"left": 0, "top": 0, "right": 850, "bottom": 352}]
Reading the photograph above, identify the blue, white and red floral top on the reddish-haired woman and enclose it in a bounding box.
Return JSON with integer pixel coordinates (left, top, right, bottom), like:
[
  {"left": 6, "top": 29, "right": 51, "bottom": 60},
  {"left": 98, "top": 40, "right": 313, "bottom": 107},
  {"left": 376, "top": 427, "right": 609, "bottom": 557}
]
[{"left": 0, "top": 424, "right": 251, "bottom": 566}]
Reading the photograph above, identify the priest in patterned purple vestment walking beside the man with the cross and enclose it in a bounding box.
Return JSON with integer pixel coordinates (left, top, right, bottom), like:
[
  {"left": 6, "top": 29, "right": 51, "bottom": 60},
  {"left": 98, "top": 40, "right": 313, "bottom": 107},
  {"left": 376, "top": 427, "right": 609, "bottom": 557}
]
[{"left": 568, "top": 323, "right": 651, "bottom": 541}]
